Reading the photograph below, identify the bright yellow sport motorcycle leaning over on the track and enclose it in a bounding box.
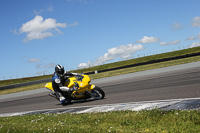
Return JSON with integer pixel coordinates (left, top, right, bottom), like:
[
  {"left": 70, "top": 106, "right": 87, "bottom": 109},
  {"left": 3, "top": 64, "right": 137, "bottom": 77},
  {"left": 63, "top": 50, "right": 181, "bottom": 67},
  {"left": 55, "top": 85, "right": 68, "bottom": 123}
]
[{"left": 45, "top": 74, "right": 105, "bottom": 104}]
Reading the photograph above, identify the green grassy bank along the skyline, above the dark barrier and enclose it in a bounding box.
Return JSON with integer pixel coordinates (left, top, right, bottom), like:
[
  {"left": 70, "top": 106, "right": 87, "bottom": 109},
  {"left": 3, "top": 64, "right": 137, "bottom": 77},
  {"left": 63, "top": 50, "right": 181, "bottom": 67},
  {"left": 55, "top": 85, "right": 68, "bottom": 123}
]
[{"left": 0, "top": 47, "right": 200, "bottom": 86}]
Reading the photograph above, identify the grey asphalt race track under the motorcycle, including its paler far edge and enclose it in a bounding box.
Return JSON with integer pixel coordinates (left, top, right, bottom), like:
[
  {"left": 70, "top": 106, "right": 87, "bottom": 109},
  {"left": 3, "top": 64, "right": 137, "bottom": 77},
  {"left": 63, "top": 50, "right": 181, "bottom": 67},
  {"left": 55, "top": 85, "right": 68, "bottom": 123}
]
[{"left": 0, "top": 62, "right": 200, "bottom": 114}]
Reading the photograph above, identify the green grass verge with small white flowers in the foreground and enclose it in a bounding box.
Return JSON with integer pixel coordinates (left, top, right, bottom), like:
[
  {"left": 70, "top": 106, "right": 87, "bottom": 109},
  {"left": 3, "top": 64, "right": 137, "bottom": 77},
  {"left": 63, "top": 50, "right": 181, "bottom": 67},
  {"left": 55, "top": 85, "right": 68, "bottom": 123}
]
[{"left": 0, "top": 109, "right": 200, "bottom": 133}]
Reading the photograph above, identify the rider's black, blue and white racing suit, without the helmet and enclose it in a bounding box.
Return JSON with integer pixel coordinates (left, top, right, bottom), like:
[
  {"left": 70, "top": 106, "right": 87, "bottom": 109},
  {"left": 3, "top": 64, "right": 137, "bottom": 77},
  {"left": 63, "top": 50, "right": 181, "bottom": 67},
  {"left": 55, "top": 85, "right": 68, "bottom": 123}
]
[{"left": 52, "top": 72, "right": 76, "bottom": 104}]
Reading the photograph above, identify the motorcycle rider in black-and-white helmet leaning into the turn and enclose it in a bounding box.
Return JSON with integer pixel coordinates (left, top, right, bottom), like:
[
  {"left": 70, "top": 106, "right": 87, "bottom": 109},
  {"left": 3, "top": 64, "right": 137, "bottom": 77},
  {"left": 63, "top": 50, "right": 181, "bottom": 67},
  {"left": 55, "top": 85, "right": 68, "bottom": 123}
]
[{"left": 50, "top": 65, "right": 76, "bottom": 104}]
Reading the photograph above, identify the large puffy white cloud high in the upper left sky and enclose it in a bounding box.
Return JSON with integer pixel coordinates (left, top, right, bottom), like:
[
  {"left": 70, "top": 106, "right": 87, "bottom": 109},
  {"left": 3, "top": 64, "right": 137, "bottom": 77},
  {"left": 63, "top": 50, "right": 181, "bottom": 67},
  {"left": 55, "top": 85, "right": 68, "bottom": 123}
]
[{"left": 19, "top": 16, "right": 67, "bottom": 42}]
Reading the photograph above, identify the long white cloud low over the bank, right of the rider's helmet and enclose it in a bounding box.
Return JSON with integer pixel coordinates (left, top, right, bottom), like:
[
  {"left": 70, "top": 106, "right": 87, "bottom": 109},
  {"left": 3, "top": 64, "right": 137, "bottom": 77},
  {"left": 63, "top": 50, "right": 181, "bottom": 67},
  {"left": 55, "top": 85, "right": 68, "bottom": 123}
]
[{"left": 78, "top": 44, "right": 144, "bottom": 68}]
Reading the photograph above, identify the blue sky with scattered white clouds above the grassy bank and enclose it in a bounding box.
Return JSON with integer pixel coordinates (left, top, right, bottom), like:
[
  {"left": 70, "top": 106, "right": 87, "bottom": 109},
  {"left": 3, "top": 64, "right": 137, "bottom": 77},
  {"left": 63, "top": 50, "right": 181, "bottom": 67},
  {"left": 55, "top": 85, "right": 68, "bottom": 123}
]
[{"left": 0, "top": 0, "right": 200, "bottom": 80}]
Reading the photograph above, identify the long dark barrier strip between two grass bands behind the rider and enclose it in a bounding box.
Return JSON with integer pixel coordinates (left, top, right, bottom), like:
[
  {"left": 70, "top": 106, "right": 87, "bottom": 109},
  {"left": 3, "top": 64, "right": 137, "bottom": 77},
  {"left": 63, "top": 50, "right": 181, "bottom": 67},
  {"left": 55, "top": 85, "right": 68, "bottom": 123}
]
[{"left": 0, "top": 52, "right": 200, "bottom": 90}]
